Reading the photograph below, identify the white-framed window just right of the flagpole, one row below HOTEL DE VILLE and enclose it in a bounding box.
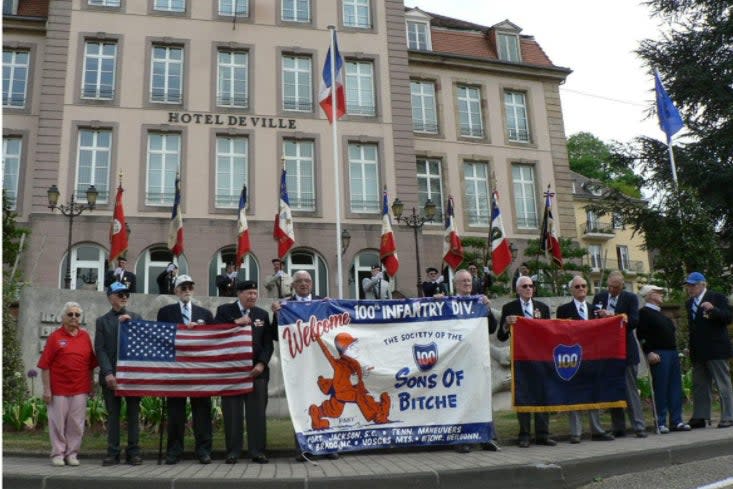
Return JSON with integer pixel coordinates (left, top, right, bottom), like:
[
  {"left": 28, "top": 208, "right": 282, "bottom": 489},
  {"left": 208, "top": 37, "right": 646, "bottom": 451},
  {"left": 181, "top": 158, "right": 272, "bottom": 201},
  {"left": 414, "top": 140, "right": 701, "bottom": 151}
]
[{"left": 349, "top": 143, "right": 382, "bottom": 213}]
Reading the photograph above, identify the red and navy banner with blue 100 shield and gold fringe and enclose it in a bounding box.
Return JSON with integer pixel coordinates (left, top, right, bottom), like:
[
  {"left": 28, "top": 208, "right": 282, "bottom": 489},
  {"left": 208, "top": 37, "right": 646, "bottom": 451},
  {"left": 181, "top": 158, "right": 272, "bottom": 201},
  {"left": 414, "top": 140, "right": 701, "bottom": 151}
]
[{"left": 511, "top": 315, "right": 626, "bottom": 413}]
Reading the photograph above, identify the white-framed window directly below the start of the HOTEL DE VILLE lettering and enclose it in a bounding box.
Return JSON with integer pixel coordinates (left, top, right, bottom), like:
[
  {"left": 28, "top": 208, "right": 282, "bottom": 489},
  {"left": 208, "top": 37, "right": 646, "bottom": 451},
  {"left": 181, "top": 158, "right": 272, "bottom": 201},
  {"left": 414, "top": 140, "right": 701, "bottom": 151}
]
[{"left": 145, "top": 132, "right": 181, "bottom": 206}]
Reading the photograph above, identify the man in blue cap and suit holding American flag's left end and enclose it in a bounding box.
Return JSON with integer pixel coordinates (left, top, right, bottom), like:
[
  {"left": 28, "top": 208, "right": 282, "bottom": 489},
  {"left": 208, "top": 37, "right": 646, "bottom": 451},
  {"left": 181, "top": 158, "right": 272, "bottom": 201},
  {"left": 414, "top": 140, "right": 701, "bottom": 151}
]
[{"left": 94, "top": 282, "right": 143, "bottom": 467}]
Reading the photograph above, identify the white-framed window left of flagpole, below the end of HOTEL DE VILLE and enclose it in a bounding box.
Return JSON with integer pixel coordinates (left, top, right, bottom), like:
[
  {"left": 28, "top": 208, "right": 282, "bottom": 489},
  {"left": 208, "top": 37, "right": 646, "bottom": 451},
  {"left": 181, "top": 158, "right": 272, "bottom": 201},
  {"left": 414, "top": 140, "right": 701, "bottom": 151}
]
[{"left": 283, "top": 139, "right": 316, "bottom": 212}]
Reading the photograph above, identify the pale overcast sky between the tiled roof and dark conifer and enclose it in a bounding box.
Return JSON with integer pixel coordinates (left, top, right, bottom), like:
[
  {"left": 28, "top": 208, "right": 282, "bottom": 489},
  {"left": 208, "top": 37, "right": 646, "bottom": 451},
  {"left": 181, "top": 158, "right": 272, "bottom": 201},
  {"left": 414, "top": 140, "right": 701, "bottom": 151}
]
[{"left": 405, "top": 0, "right": 664, "bottom": 142}]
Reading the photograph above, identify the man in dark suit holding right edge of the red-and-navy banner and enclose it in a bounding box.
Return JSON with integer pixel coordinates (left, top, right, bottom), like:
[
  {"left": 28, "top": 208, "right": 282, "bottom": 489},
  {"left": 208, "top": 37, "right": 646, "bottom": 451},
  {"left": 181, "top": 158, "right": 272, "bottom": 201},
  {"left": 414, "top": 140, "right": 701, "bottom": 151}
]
[{"left": 593, "top": 270, "right": 646, "bottom": 438}]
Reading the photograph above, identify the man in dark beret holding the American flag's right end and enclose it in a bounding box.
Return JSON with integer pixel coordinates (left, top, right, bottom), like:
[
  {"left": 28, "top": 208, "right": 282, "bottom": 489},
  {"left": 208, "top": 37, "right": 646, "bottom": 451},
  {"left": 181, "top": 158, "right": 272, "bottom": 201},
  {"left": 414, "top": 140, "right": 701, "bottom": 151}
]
[{"left": 214, "top": 280, "right": 274, "bottom": 464}]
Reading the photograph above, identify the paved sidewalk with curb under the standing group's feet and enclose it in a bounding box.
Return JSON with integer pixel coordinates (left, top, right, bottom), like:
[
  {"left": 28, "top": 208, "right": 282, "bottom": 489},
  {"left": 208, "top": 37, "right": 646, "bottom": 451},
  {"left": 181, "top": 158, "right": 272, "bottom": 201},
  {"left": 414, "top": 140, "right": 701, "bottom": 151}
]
[{"left": 3, "top": 427, "right": 733, "bottom": 489}]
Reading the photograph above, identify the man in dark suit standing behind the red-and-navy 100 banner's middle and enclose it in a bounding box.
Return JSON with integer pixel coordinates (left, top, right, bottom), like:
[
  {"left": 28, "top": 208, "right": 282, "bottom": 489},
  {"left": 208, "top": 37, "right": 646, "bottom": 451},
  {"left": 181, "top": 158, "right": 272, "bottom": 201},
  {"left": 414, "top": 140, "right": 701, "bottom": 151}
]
[{"left": 556, "top": 275, "right": 614, "bottom": 443}]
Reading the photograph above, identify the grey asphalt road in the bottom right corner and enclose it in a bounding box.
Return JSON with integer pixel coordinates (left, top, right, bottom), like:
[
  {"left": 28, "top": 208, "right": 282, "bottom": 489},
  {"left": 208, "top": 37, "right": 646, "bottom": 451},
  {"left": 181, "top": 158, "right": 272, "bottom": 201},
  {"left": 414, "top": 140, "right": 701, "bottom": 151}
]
[{"left": 579, "top": 455, "right": 733, "bottom": 489}]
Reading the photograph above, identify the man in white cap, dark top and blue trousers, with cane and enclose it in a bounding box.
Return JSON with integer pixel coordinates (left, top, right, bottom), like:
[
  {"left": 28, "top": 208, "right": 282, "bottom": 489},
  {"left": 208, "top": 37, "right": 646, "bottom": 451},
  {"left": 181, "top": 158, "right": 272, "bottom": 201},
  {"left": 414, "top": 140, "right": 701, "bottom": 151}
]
[{"left": 636, "top": 285, "right": 690, "bottom": 434}]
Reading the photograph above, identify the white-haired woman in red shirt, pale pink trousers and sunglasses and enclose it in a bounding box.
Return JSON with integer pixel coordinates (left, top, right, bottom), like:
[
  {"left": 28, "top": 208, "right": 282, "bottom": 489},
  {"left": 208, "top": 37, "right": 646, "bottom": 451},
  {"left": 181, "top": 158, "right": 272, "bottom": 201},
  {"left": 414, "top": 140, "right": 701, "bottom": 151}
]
[{"left": 38, "top": 302, "right": 97, "bottom": 467}]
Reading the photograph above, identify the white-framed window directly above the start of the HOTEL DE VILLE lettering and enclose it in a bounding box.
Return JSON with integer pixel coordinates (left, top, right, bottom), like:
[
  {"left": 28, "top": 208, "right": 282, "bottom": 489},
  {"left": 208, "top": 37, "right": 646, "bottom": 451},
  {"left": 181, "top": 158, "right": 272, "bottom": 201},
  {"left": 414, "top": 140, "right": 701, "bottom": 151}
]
[{"left": 150, "top": 45, "right": 183, "bottom": 104}]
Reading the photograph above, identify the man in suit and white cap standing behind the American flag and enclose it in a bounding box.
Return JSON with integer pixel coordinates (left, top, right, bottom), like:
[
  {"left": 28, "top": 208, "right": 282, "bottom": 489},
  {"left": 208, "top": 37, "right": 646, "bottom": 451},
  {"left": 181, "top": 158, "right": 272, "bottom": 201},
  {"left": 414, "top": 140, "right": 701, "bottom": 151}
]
[{"left": 158, "top": 275, "right": 214, "bottom": 465}]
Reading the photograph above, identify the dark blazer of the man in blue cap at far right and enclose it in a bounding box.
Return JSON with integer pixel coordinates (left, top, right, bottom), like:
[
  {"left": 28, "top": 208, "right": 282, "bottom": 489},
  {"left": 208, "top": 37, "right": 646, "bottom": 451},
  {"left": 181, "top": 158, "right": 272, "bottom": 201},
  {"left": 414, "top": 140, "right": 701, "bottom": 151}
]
[{"left": 685, "top": 290, "right": 733, "bottom": 362}]
